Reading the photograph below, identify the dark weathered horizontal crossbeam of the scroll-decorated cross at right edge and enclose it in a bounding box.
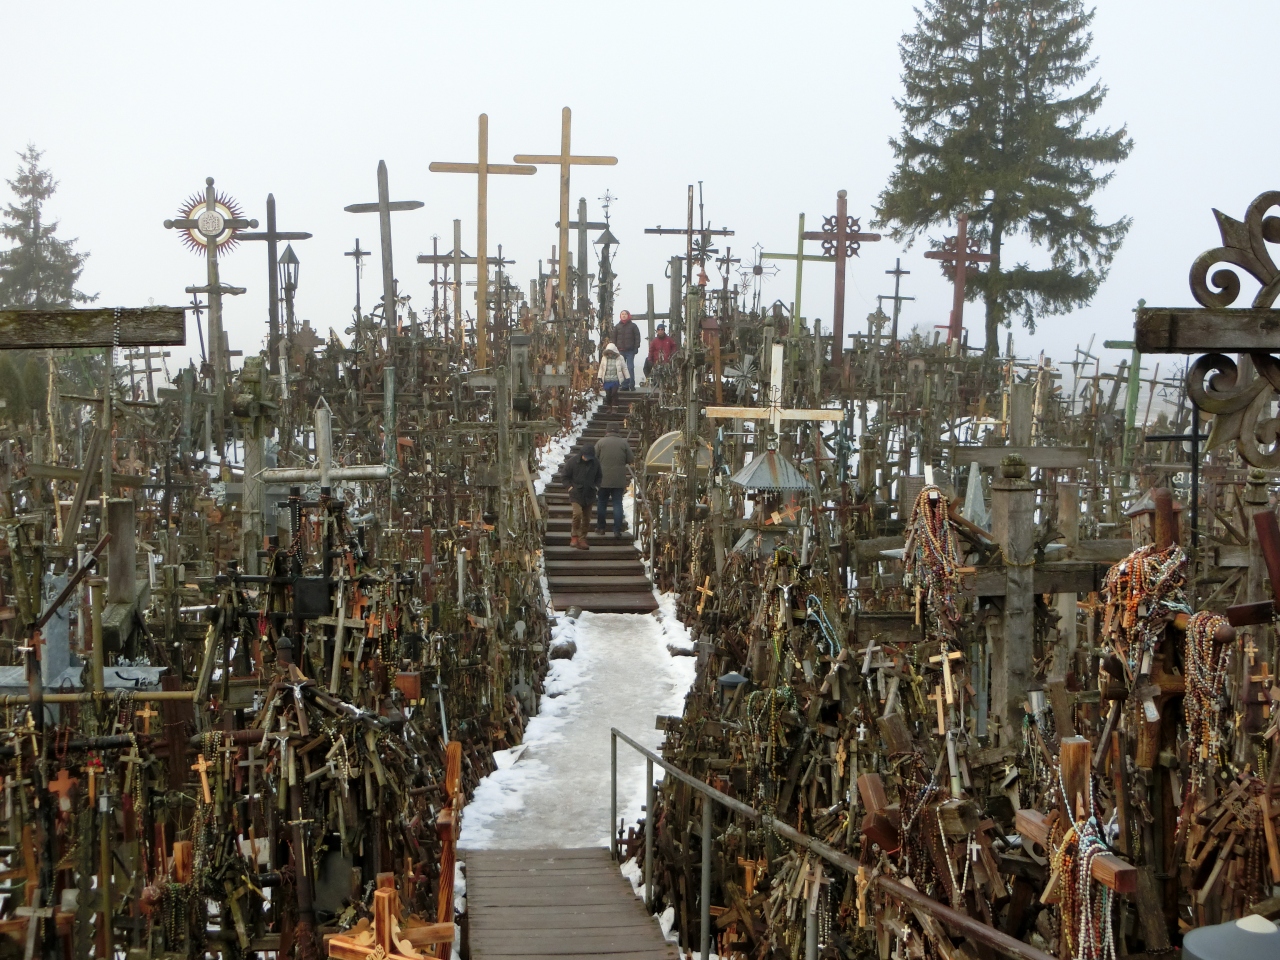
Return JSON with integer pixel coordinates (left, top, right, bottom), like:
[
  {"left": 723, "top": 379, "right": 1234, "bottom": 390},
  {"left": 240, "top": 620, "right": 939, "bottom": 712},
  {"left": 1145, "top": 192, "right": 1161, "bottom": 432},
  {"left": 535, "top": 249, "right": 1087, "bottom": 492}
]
[{"left": 1134, "top": 307, "right": 1280, "bottom": 353}]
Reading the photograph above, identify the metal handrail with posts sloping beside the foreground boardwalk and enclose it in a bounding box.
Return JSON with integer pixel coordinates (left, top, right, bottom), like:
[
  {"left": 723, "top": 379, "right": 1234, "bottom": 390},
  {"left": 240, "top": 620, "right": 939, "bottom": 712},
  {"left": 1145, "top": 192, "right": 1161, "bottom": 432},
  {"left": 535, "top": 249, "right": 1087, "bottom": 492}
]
[{"left": 609, "top": 727, "right": 1057, "bottom": 960}]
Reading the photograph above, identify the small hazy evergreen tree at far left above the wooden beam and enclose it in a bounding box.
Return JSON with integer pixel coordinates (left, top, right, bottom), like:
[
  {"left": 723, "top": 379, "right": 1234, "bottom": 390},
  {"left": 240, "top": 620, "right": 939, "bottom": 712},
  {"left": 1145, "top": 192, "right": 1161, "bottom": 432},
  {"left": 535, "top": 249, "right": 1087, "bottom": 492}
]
[{"left": 0, "top": 143, "right": 97, "bottom": 307}]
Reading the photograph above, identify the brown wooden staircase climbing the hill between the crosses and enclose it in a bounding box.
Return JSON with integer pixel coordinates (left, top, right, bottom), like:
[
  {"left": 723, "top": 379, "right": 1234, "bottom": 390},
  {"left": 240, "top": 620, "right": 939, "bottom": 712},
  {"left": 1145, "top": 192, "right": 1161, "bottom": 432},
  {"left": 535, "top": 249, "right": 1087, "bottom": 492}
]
[{"left": 543, "top": 392, "right": 658, "bottom": 613}]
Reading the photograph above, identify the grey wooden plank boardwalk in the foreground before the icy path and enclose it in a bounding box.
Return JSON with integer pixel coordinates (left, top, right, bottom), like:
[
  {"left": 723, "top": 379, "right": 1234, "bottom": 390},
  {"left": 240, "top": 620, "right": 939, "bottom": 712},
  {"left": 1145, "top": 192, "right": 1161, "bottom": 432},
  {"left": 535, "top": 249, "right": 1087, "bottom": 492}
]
[{"left": 458, "top": 847, "right": 678, "bottom": 960}]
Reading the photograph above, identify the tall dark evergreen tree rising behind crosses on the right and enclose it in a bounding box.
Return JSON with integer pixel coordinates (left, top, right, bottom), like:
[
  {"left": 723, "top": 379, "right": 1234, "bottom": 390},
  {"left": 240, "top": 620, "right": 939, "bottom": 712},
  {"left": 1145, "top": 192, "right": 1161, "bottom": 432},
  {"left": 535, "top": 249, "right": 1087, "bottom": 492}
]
[{"left": 876, "top": 0, "right": 1133, "bottom": 353}]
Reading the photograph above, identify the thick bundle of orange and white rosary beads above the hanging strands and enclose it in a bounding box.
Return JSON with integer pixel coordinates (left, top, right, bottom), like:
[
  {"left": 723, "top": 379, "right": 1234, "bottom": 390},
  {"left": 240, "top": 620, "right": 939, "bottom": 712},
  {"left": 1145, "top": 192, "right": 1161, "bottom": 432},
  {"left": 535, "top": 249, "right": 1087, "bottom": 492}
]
[{"left": 1102, "top": 544, "right": 1192, "bottom": 675}]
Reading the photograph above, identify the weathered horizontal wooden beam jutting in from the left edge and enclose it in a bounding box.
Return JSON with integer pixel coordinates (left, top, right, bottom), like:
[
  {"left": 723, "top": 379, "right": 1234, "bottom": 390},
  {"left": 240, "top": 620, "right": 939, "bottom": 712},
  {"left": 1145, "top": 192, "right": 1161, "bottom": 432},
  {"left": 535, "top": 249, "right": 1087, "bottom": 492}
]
[{"left": 0, "top": 307, "right": 187, "bottom": 349}]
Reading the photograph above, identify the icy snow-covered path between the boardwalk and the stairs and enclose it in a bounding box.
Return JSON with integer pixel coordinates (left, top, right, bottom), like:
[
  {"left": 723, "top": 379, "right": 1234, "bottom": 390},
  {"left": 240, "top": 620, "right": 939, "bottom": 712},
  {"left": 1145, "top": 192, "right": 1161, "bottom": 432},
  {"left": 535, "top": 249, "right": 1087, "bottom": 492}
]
[{"left": 461, "top": 599, "right": 694, "bottom": 849}]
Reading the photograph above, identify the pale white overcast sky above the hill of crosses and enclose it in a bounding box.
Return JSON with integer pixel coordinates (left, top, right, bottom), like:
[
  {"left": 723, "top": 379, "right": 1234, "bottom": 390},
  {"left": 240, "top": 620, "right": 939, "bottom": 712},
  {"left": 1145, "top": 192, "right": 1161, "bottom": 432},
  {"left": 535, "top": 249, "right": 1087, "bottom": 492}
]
[{"left": 0, "top": 0, "right": 1280, "bottom": 378}]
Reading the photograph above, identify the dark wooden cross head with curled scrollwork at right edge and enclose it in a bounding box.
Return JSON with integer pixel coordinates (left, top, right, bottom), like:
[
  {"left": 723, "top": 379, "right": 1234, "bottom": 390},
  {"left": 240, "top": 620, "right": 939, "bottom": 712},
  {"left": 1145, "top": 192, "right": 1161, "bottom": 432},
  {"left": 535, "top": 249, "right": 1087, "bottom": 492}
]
[{"left": 1134, "top": 191, "right": 1280, "bottom": 468}]
